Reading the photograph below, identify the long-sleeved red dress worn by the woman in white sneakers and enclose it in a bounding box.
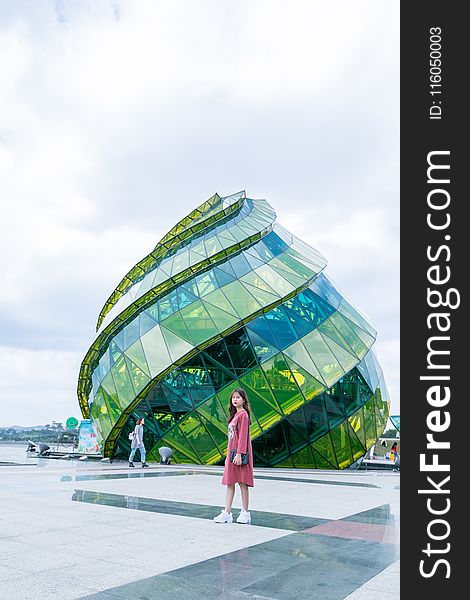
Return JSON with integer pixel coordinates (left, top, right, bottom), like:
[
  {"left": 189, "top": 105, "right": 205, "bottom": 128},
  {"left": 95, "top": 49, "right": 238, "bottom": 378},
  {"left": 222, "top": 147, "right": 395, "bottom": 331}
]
[{"left": 222, "top": 409, "right": 254, "bottom": 487}]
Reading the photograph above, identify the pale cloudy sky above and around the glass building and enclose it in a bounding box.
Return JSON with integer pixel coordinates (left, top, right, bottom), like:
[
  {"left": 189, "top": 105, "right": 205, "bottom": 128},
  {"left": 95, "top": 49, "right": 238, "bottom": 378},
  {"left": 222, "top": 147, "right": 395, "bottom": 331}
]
[{"left": 0, "top": 0, "right": 400, "bottom": 426}]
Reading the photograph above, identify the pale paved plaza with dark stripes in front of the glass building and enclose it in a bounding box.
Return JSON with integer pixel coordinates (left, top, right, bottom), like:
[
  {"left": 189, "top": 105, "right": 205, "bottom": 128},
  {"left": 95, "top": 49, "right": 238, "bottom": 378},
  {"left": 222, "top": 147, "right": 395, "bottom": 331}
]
[{"left": 0, "top": 446, "right": 400, "bottom": 600}]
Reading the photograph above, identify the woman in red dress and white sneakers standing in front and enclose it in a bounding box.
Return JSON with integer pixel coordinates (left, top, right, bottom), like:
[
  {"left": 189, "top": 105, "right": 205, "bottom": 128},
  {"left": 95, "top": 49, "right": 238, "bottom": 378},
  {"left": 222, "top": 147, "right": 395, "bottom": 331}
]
[{"left": 214, "top": 388, "right": 254, "bottom": 524}]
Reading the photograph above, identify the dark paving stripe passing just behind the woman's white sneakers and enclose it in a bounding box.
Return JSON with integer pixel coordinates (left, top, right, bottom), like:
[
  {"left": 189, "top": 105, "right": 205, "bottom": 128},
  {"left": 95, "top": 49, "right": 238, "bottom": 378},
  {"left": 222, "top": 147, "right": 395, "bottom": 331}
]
[{"left": 72, "top": 490, "right": 328, "bottom": 531}]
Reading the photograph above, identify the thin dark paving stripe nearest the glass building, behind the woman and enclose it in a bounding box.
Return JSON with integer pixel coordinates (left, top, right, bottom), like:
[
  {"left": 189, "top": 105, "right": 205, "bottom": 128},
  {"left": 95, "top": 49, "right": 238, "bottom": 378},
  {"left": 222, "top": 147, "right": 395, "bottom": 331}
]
[{"left": 66, "top": 468, "right": 379, "bottom": 488}]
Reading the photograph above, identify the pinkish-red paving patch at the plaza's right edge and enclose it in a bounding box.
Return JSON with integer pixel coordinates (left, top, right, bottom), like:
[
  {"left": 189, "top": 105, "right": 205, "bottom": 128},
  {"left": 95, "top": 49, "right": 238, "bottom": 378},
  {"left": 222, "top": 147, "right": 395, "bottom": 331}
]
[{"left": 304, "top": 520, "right": 400, "bottom": 544}]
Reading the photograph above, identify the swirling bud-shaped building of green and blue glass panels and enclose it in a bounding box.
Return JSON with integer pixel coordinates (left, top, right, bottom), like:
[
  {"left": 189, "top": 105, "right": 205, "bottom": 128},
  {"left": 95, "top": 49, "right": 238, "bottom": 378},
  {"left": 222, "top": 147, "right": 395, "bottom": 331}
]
[{"left": 78, "top": 192, "right": 390, "bottom": 469}]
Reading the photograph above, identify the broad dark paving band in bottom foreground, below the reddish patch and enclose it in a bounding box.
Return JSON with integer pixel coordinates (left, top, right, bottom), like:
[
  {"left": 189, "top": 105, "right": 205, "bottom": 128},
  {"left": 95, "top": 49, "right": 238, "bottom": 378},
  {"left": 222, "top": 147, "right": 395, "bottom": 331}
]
[{"left": 79, "top": 533, "right": 398, "bottom": 600}]
